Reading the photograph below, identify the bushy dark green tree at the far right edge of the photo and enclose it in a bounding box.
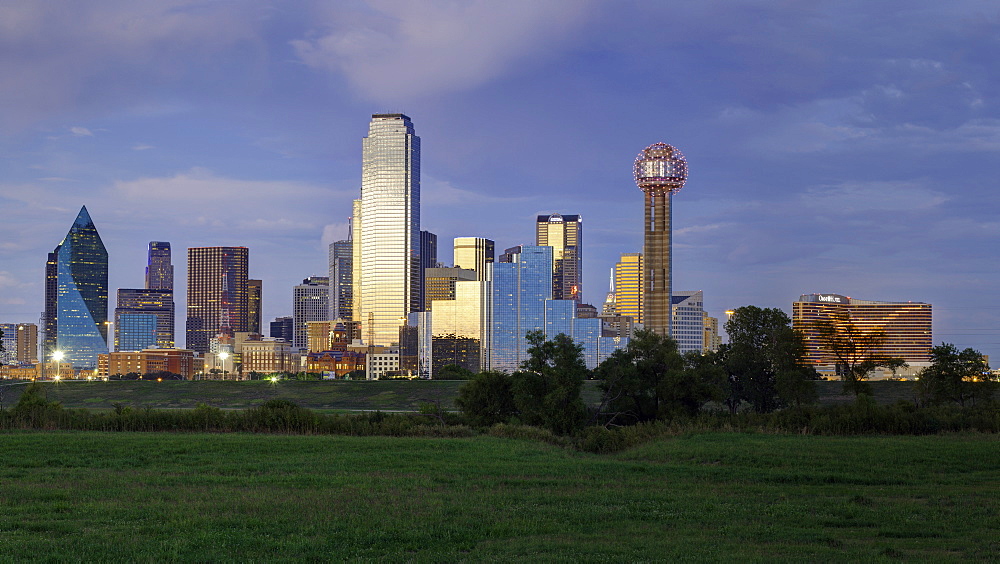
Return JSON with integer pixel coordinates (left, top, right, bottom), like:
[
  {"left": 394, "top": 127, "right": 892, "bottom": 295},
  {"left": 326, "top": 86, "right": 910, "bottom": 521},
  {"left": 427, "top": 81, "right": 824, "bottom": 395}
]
[{"left": 918, "top": 343, "right": 997, "bottom": 407}]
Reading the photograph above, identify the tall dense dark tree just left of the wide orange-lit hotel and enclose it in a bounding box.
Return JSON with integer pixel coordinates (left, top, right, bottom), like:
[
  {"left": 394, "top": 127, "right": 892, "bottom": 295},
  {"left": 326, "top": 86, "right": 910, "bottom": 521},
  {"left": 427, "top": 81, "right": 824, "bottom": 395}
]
[{"left": 719, "top": 306, "right": 816, "bottom": 413}]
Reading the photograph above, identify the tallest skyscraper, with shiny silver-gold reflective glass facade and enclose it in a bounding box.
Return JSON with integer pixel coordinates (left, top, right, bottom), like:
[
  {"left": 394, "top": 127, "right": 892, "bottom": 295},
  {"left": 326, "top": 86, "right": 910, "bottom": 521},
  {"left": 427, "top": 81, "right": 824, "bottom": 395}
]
[{"left": 354, "top": 114, "right": 423, "bottom": 345}]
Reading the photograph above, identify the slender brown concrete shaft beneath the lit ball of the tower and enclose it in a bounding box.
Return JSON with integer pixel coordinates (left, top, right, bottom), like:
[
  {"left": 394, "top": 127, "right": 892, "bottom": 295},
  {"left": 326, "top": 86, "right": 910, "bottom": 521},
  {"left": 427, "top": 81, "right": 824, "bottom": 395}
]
[{"left": 643, "top": 190, "right": 672, "bottom": 335}]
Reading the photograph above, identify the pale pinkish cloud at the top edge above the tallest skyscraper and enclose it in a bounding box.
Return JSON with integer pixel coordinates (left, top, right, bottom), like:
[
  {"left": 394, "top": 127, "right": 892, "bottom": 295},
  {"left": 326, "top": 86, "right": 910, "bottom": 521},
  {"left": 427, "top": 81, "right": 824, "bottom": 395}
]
[{"left": 291, "top": 0, "right": 591, "bottom": 102}]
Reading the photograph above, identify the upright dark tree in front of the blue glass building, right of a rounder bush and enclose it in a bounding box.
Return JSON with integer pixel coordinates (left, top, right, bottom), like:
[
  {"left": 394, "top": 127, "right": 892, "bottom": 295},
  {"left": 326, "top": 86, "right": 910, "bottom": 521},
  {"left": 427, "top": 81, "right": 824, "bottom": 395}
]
[{"left": 511, "top": 331, "right": 589, "bottom": 434}]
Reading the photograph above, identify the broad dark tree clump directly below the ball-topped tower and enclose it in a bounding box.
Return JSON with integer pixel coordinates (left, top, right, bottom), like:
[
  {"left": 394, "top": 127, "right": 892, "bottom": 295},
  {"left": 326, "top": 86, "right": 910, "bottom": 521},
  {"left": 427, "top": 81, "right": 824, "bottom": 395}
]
[{"left": 596, "top": 330, "right": 725, "bottom": 423}]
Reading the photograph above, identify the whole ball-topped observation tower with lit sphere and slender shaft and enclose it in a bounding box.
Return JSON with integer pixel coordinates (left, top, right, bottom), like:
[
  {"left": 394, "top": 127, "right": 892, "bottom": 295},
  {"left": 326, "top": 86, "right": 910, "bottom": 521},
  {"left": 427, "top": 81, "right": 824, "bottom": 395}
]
[{"left": 635, "top": 143, "right": 687, "bottom": 335}]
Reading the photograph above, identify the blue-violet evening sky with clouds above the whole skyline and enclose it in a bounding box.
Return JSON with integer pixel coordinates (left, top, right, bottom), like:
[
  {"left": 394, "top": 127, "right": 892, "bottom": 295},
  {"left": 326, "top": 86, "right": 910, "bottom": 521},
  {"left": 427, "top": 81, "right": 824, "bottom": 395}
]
[{"left": 0, "top": 0, "right": 1000, "bottom": 359}]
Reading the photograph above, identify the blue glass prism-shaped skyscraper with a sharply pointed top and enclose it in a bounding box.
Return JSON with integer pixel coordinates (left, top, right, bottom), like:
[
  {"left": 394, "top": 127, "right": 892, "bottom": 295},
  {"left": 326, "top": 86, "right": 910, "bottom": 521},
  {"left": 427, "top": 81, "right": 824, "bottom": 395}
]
[{"left": 42, "top": 206, "right": 108, "bottom": 368}]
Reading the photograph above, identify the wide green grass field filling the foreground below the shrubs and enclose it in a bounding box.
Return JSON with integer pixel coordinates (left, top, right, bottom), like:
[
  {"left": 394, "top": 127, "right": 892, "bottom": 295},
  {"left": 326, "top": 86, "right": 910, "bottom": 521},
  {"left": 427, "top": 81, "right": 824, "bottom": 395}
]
[{"left": 0, "top": 432, "right": 1000, "bottom": 562}]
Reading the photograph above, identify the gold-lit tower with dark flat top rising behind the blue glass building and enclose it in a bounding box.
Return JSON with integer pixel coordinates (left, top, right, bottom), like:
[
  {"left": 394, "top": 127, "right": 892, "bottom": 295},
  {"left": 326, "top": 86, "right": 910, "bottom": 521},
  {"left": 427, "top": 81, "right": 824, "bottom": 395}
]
[{"left": 535, "top": 213, "right": 583, "bottom": 302}]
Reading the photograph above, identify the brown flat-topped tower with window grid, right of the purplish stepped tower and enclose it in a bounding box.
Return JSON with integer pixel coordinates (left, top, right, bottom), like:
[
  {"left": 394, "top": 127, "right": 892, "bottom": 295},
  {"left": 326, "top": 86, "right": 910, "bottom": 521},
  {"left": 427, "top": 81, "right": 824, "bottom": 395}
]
[{"left": 186, "top": 247, "right": 250, "bottom": 353}]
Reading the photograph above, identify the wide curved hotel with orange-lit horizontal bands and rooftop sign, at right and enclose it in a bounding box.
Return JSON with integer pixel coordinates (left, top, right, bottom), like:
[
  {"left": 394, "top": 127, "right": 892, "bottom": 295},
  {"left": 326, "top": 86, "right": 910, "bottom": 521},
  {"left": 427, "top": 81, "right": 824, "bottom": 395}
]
[{"left": 792, "top": 294, "right": 933, "bottom": 365}]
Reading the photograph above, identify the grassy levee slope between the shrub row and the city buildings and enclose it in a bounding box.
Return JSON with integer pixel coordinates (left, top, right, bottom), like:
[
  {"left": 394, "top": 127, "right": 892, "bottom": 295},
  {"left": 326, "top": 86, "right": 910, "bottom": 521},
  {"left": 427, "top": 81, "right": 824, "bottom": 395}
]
[{"left": 0, "top": 380, "right": 915, "bottom": 411}]
